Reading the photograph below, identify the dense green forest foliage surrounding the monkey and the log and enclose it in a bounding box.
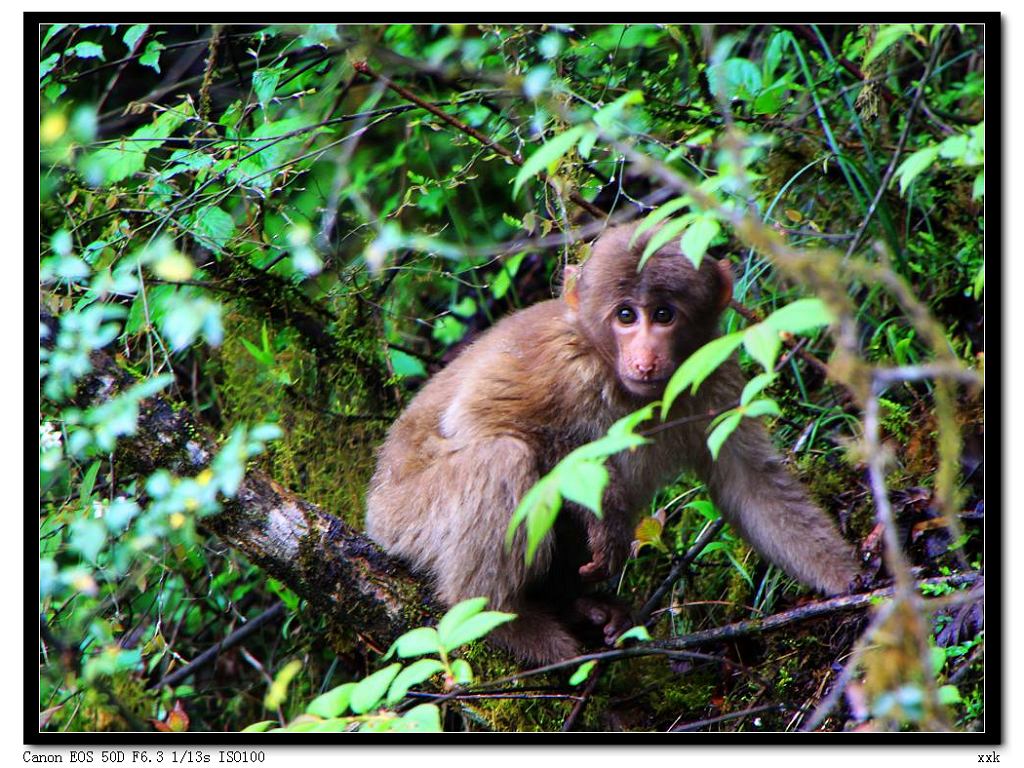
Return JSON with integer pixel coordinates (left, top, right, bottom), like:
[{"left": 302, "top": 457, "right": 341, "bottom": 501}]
[{"left": 39, "top": 25, "right": 985, "bottom": 730}]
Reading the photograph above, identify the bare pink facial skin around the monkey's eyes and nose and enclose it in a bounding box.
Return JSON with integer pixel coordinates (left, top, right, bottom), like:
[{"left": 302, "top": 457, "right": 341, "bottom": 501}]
[{"left": 610, "top": 301, "right": 679, "bottom": 398}]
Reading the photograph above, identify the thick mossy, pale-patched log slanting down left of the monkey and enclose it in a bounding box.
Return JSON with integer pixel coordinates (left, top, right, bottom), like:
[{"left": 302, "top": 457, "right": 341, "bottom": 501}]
[{"left": 60, "top": 318, "right": 439, "bottom": 650}]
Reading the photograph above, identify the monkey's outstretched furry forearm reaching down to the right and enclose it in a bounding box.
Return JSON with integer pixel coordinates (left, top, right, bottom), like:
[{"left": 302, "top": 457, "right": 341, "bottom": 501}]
[{"left": 703, "top": 419, "right": 859, "bottom": 594}]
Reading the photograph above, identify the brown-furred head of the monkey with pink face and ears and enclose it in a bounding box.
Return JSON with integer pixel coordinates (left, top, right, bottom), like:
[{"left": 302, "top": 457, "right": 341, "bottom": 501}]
[{"left": 564, "top": 224, "right": 732, "bottom": 399}]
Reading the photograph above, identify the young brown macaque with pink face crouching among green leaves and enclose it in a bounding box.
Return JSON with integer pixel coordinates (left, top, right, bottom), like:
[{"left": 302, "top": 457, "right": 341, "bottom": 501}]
[{"left": 367, "top": 226, "right": 858, "bottom": 664}]
